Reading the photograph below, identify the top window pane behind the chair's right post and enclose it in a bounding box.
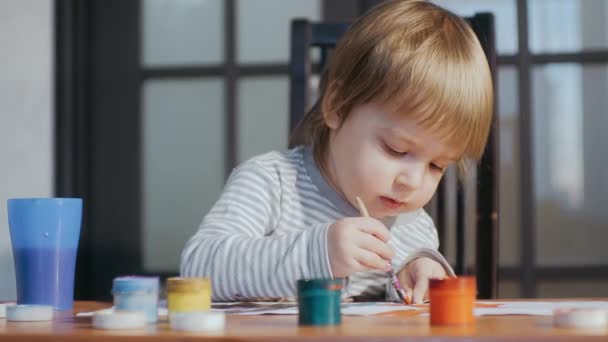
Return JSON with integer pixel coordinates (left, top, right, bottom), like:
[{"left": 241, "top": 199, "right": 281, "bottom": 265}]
[{"left": 432, "top": 0, "right": 517, "bottom": 55}]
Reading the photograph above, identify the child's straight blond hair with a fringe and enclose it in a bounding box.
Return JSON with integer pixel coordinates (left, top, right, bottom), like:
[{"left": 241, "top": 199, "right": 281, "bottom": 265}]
[{"left": 290, "top": 0, "right": 493, "bottom": 175}]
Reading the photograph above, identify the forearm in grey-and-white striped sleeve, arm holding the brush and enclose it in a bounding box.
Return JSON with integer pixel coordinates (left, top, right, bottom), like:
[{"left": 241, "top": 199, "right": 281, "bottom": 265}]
[{"left": 181, "top": 224, "right": 331, "bottom": 301}]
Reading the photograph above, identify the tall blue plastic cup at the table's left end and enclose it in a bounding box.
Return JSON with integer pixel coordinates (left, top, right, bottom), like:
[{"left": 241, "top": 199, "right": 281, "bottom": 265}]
[{"left": 7, "top": 198, "right": 82, "bottom": 310}]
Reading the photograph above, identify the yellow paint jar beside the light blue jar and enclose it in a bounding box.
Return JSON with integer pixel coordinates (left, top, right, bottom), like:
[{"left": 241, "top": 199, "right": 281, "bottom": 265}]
[{"left": 167, "top": 277, "right": 211, "bottom": 314}]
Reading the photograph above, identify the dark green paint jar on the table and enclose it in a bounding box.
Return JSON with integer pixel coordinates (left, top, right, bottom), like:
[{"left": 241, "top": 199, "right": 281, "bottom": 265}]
[{"left": 298, "top": 278, "right": 343, "bottom": 326}]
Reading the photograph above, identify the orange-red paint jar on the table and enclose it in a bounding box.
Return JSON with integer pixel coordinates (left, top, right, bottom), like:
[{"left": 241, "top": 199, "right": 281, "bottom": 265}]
[{"left": 429, "top": 277, "right": 477, "bottom": 325}]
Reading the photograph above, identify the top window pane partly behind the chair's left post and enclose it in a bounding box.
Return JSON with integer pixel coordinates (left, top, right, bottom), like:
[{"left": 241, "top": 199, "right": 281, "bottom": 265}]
[{"left": 237, "top": 0, "right": 321, "bottom": 63}]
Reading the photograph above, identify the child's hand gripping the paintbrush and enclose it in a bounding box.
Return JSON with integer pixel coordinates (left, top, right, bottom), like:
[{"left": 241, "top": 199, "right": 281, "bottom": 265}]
[{"left": 327, "top": 217, "right": 394, "bottom": 278}]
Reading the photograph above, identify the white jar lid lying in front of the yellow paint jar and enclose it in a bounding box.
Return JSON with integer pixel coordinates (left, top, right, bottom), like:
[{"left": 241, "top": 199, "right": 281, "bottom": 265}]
[{"left": 169, "top": 311, "right": 226, "bottom": 331}]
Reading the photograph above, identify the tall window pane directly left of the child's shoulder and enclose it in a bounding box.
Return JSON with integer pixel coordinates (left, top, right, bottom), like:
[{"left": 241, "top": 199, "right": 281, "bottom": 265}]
[{"left": 142, "top": 79, "right": 225, "bottom": 272}]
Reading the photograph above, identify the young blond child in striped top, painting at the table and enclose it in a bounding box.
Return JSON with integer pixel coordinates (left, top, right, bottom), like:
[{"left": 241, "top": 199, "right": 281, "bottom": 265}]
[{"left": 181, "top": 0, "right": 493, "bottom": 303}]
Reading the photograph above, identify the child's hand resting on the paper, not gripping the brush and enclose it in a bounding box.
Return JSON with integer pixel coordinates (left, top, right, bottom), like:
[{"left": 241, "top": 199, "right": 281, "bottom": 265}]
[{"left": 397, "top": 257, "right": 447, "bottom": 304}]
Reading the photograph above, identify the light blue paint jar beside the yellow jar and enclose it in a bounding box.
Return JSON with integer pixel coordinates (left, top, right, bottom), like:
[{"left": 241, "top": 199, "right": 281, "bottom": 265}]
[{"left": 112, "top": 276, "right": 159, "bottom": 323}]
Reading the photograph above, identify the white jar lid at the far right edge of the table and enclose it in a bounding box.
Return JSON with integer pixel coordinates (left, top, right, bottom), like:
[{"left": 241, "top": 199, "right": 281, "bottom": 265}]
[{"left": 553, "top": 308, "right": 608, "bottom": 329}]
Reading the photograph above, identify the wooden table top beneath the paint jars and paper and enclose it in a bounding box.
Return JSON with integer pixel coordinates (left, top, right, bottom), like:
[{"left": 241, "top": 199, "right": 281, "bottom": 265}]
[{"left": 0, "top": 302, "right": 608, "bottom": 342}]
